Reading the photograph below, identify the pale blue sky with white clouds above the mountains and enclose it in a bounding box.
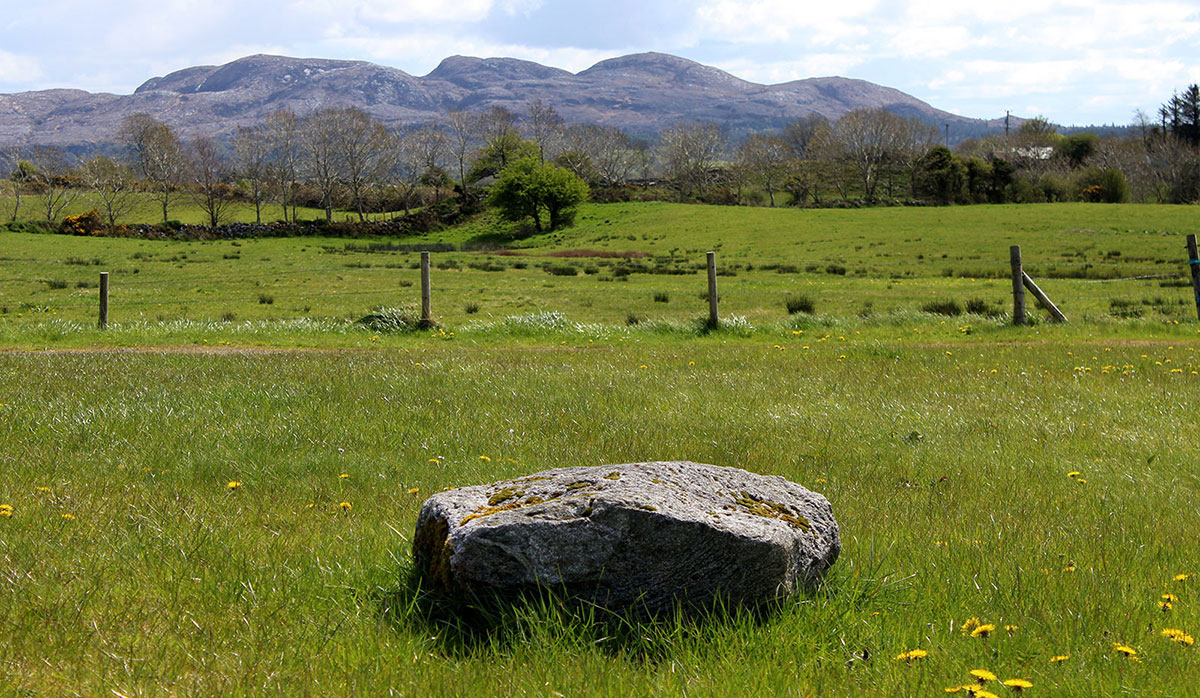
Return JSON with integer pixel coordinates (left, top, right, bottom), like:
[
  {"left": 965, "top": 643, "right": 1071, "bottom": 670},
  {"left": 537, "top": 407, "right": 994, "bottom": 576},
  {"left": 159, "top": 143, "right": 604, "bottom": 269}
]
[{"left": 0, "top": 0, "right": 1200, "bottom": 125}]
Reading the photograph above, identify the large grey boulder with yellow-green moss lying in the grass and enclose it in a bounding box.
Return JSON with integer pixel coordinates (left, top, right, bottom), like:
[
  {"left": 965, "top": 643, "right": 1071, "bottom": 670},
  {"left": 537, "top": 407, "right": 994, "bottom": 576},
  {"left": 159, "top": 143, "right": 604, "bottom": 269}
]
[{"left": 413, "top": 462, "right": 841, "bottom": 612}]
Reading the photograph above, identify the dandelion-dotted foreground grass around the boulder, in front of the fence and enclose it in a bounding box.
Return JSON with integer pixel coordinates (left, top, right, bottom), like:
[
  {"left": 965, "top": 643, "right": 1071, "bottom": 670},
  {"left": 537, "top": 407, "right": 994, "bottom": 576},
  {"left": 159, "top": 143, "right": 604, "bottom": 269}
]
[{"left": 0, "top": 333, "right": 1200, "bottom": 697}]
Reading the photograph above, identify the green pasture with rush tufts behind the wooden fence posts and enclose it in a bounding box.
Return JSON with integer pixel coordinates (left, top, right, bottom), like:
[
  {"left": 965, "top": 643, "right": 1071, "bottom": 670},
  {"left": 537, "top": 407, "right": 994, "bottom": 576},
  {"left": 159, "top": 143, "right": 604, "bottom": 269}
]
[{"left": 0, "top": 204, "right": 1200, "bottom": 340}]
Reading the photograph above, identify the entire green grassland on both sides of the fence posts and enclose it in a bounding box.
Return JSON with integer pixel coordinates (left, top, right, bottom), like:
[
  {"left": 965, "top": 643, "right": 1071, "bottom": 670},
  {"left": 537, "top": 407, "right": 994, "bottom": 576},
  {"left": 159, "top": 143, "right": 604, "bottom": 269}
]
[{"left": 0, "top": 204, "right": 1200, "bottom": 697}]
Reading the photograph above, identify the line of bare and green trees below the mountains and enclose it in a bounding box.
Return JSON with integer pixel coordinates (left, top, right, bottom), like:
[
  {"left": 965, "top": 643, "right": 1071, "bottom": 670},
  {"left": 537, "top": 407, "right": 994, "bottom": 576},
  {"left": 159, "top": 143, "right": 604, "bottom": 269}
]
[{"left": 0, "top": 85, "right": 1200, "bottom": 230}]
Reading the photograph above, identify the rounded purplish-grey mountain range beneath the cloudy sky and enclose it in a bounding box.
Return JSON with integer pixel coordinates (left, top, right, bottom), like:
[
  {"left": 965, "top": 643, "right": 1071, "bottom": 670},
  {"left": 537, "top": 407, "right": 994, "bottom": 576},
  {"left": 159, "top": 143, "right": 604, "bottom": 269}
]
[{"left": 0, "top": 53, "right": 1003, "bottom": 149}]
